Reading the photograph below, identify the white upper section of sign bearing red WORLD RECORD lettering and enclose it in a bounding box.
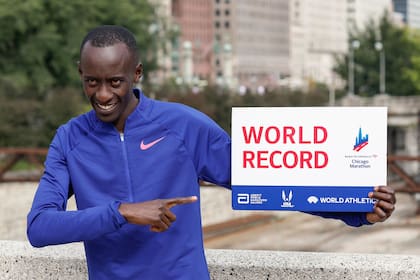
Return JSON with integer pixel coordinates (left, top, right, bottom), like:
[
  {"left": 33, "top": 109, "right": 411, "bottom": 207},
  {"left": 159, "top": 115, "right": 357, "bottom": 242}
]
[{"left": 232, "top": 107, "right": 387, "bottom": 187}]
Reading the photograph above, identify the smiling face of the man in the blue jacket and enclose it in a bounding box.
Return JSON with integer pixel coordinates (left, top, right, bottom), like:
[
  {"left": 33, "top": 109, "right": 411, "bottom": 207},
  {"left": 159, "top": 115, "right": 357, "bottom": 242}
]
[{"left": 79, "top": 42, "right": 142, "bottom": 131}]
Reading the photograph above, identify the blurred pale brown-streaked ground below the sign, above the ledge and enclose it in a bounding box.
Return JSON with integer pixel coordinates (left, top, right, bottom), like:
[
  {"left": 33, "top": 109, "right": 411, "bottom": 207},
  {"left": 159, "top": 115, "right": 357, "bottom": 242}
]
[{"left": 204, "top": 193, "right": 420, "bottom": 255}]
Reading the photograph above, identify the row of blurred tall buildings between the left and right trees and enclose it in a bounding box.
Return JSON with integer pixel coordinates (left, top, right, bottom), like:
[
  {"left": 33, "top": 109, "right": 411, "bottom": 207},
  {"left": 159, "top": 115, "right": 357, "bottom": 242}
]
[{"left": 151, "top": 0, "right": 392, "bottom": 91}]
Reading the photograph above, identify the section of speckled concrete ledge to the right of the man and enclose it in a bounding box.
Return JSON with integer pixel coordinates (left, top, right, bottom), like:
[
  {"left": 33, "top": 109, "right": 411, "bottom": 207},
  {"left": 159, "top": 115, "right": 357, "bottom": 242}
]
[{"left": 207, "top": 250, "right": 420, "bottom": 280}]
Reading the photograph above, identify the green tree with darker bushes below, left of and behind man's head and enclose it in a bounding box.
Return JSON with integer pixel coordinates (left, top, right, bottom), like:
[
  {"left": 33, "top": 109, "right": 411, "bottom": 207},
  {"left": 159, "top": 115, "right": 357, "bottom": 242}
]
[{"left": 0, "top": 0, "right": 166, "bottom": 146}]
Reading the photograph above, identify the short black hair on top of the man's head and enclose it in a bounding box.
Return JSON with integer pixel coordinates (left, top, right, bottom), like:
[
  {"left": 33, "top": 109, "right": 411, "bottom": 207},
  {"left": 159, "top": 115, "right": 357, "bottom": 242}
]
[{"left": 80, "top": 25, "right": 139, "bottom": 61}]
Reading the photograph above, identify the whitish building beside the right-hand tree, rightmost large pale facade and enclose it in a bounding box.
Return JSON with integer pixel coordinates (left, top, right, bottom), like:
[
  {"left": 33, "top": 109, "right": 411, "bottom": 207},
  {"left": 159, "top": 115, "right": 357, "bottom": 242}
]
[{"left": 290, "top": 0, "right": 392, "bottom": 87}]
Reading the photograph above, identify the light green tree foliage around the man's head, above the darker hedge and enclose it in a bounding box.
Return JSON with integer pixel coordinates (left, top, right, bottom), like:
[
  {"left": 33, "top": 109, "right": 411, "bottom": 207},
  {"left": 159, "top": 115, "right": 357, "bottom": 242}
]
[{"left": 0, "top": 0, "right": 161, "bottom": 95}]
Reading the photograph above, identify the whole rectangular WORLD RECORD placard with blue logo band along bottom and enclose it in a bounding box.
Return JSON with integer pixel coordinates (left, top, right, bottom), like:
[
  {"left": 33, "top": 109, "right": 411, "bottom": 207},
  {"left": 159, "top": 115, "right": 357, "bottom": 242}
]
[{"left": 232, "top": 107, "right": 387, "bottom": 212}]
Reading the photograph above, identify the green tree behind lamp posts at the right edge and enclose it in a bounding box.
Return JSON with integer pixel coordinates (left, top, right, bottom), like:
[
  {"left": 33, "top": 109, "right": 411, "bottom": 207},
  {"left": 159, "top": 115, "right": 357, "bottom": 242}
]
[{"left": 334, "top": 13, "right": 420, "bottom": 96}]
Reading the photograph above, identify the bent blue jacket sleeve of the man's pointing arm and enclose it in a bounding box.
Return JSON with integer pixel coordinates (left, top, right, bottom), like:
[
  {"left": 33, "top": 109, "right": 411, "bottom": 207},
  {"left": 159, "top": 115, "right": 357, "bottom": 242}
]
[{"left": 27, "top": 129, "right": 126, "bottom": 247}]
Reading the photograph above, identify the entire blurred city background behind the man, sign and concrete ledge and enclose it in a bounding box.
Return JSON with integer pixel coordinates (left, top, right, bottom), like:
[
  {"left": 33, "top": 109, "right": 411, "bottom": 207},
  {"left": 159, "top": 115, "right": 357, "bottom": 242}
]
[{"left": 0, "top": 0, "right": 420, "bottom": 253}]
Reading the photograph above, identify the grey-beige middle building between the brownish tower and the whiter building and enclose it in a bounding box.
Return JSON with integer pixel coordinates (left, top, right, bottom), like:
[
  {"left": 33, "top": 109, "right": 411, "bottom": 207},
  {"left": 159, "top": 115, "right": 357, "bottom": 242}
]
[{"left": 230, "top": 0, "right": 290, "bottom": 91}]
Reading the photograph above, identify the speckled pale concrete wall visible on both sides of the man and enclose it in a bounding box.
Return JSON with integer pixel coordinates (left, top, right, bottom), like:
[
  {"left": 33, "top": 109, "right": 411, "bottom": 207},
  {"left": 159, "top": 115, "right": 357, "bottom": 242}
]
[{"left": 0, "top": 238, "right": 420, "bottom": 280}]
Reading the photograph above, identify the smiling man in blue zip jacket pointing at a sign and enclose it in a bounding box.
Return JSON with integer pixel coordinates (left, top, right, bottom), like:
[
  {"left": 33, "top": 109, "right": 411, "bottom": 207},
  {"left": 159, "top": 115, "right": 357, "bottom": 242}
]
[{"left": 27, "top": 26, "right": 395, "bottom": 280}]
